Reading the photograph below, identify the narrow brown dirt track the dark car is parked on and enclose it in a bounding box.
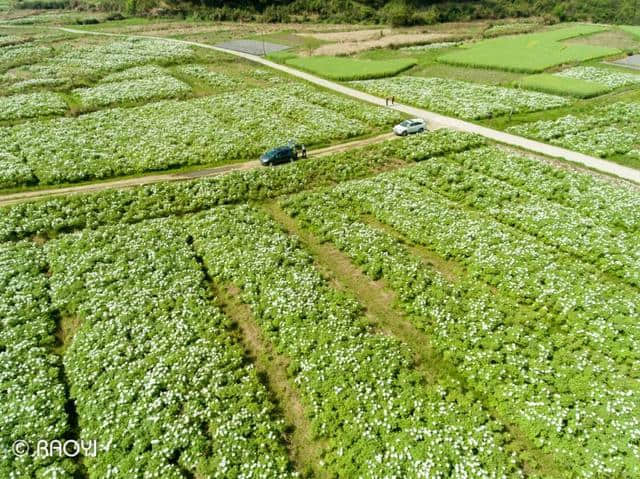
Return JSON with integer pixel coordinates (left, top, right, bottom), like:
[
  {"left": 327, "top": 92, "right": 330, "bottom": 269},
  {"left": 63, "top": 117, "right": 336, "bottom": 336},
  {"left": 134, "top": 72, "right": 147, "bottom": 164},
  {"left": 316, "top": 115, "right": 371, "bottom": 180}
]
[{"left": 0, "top": 133, "right": 398, "bottom": 206}]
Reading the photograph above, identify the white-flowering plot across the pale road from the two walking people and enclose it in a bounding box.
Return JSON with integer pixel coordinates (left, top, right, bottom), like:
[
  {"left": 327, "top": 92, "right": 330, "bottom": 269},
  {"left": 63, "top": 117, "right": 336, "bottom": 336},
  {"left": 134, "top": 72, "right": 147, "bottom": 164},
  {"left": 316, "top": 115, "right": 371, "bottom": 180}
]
[{"left": 351, "top": 76, "right": 570, "bottom": 120}]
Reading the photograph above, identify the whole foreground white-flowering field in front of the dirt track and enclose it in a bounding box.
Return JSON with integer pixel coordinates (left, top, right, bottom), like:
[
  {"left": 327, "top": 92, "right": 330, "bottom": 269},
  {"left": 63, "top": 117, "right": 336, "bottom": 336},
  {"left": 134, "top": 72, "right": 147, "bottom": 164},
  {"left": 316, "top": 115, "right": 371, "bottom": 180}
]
[{"left": 0, "top": 130, "right": 640, "bottom": 478}]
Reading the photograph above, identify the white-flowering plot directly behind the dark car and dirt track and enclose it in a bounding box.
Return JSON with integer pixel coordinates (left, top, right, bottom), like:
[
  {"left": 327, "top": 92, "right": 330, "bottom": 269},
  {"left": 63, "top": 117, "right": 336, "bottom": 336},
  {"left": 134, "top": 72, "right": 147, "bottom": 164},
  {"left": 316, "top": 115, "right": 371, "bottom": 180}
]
[{"left": 0, "top": 80, "right": 398, "bottom": 188}]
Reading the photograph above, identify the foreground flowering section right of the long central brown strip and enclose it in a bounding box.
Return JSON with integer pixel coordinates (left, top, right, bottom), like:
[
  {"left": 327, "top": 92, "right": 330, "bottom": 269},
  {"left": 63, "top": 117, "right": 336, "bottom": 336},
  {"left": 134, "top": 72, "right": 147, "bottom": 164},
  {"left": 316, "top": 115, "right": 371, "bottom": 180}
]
[{"left": 285, "top": 141, "right": 640, "bottom": 477}]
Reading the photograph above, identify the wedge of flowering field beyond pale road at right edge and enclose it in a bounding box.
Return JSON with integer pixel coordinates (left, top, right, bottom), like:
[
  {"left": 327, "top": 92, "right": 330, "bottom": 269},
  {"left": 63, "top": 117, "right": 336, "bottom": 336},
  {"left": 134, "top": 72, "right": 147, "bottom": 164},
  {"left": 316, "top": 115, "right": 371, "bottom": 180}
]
[{"left": 508, "top": 102, "right": 640, "bottom": 167}]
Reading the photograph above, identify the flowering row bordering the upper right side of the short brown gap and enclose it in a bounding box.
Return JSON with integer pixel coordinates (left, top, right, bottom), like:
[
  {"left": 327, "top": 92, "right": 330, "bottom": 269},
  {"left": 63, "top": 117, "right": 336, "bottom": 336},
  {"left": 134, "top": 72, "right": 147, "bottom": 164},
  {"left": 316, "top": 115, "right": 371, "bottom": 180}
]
[{"left": 316, "top": 171, "right": 640, "bottom": 340}]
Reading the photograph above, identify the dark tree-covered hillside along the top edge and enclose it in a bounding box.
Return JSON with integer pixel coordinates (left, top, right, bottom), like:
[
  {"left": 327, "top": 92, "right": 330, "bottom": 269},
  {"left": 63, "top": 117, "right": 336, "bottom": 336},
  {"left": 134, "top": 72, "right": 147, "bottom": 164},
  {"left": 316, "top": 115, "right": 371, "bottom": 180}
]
[{"left": 11, "top": 0, "right": 640, "bottom": 25}]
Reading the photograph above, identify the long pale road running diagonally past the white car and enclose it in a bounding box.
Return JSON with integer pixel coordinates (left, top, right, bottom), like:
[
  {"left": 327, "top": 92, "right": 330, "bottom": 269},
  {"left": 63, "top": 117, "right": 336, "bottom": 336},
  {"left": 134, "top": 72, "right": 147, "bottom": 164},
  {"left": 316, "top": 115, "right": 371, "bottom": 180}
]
[{"left": 53, "top": 28, "right": 640, "bottom": 183}]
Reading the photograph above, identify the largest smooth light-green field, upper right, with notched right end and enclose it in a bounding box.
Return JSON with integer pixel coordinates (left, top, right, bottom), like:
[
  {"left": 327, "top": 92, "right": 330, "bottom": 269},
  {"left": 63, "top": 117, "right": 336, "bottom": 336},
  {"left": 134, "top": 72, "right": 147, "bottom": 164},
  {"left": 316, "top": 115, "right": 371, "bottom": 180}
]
[{"left": 439, "top": 25, "right": 620, "bottom": 73}]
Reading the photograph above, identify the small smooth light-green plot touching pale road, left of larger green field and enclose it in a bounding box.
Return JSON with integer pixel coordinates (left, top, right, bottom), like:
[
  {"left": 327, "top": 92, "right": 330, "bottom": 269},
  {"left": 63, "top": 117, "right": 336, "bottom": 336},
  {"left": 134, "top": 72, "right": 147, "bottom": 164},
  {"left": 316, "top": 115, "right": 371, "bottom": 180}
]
[{"left": 286, "top": 56, "right": 417, "bottom": 81}]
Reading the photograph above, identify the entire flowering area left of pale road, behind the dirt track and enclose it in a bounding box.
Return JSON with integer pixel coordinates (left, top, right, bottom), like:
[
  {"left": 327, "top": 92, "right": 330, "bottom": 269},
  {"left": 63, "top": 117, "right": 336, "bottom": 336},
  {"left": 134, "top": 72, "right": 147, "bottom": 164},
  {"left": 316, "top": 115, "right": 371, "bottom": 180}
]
[{"left": 0, "top": 30, "right": 402, "bottom": 188}]
